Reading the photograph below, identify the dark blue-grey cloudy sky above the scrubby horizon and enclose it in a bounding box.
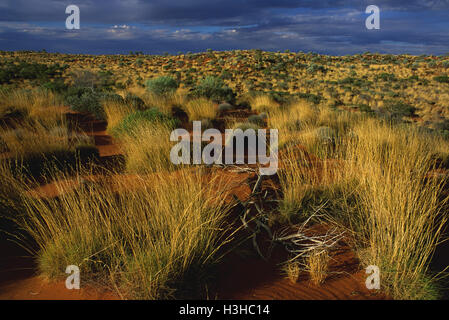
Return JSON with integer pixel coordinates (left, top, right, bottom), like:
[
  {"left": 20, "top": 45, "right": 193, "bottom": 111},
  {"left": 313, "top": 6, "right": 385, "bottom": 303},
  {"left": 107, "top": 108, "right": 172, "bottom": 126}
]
[{"left": 0, "top": 0, "right": 449, "bottom": 55}]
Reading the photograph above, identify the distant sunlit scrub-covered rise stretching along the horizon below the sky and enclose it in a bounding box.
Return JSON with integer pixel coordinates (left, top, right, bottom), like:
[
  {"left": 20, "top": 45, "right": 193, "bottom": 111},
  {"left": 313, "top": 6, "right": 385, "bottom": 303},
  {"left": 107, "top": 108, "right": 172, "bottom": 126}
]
[{"left": 0, "top": 50, "right": 448, "bottom": 135}]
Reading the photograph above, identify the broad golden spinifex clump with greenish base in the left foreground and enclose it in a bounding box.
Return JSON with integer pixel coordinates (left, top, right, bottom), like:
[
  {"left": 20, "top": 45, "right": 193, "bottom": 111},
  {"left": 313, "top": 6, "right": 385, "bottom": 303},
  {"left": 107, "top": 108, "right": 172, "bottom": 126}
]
[{"left": 16, "top": 170, "right": 234, "bottom": 299}]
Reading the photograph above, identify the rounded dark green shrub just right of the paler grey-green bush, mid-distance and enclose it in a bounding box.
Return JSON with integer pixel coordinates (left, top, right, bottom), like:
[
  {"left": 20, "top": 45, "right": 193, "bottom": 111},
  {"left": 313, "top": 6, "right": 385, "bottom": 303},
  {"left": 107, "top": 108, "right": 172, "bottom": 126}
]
[{"left": 192, "top": 76, "right": 235, "bottom": 103}]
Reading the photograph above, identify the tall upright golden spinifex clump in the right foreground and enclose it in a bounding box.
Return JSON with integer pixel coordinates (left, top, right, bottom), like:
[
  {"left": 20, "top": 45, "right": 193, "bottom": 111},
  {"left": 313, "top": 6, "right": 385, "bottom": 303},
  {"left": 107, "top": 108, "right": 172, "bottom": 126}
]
[{"left": 348, "top": 120, "right": 448, "bottom": 299}]
